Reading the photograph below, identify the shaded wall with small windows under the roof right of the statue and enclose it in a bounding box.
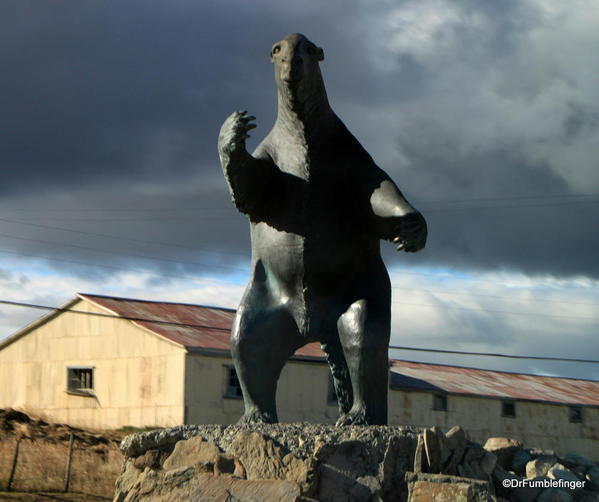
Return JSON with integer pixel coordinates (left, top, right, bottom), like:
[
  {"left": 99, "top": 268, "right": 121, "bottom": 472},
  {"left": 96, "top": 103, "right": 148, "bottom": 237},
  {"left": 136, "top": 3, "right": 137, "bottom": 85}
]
[{"left": 389, "top": 390, "right": 599, "bottom": 461}]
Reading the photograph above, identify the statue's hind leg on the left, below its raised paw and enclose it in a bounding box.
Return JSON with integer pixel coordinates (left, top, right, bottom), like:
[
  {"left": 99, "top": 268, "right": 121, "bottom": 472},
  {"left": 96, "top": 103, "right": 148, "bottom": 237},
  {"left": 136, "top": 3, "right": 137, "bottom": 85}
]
[{"left": 231, "top": 299, "right": 305, "bottom": 423}]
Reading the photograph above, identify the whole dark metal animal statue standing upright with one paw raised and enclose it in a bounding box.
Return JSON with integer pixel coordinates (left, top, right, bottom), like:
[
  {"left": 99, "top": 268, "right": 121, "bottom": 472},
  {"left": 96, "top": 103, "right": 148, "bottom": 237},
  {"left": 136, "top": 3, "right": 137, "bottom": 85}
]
[{"left": 218, "top": 34, "right": 427, "bottom": 425}]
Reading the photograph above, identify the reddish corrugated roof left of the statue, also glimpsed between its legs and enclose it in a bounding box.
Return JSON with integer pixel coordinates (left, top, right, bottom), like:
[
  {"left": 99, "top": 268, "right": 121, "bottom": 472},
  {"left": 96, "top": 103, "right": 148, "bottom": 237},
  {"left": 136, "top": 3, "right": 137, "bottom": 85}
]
[{"left": 77, "top": 293, "right": 324, "bottom": 358}]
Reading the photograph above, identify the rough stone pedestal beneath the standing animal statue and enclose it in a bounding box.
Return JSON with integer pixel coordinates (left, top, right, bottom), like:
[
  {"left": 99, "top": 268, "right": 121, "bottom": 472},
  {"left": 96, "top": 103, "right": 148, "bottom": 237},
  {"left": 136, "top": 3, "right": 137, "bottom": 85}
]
[{"left": 115, "top": 424, "right": 502, "bottom": 502}]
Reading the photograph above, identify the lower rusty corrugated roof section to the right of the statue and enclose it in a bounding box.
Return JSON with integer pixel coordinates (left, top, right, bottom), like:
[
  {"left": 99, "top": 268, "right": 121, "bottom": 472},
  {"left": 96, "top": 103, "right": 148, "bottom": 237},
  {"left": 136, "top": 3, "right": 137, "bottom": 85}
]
[{"left": 391, "top": 361, "right": 599, "bottom": 406}]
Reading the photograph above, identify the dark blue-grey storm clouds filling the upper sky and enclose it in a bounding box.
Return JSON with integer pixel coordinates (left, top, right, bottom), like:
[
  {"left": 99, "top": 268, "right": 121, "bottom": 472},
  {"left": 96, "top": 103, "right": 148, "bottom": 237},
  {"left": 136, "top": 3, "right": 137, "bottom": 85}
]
[{"left": 0, "top": 0, "right": 599, "bottom": 276}]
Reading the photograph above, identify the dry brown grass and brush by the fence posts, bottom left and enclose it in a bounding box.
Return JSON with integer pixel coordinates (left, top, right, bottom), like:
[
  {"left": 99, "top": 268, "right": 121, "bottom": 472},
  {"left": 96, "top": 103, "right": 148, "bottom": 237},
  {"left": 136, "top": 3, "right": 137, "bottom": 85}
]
[{"left": 0, "top": 410, "right": 122, "bottom": 500}]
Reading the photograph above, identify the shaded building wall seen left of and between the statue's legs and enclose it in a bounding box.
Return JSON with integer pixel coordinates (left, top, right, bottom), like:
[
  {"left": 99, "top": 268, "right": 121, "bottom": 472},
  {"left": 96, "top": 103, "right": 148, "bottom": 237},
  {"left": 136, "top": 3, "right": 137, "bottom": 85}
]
[{"left": 185, "top": 354, "right": 337, "bottom": 424}]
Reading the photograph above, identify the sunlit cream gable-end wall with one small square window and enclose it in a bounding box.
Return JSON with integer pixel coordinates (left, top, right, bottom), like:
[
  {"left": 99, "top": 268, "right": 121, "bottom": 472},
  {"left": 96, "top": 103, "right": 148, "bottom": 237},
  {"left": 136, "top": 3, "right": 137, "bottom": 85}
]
[{"left": 0, "top": 301, "right": 185, "bottom": 428}]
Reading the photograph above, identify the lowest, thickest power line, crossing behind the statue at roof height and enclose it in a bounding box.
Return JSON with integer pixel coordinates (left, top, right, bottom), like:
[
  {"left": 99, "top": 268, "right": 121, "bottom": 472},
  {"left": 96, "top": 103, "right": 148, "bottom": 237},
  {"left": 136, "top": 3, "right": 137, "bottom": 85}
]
[{"left": 0, "top": 300, "right": 599, "bottom": 364}]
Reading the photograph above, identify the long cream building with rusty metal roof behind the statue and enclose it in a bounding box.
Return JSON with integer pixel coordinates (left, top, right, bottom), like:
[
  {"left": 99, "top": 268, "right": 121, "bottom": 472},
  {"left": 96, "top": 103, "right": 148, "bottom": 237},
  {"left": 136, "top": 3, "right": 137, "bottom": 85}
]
[{"left": 0, "top": 294, "right": 599, "bottom": 460}]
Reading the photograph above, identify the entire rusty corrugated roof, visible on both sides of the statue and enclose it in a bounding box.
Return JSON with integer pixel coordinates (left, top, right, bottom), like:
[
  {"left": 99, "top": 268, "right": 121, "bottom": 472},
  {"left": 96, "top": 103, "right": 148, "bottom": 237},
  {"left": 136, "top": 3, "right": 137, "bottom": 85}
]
[{"left": 78, "top": 294, "right": 599, "bottom": 406}]
